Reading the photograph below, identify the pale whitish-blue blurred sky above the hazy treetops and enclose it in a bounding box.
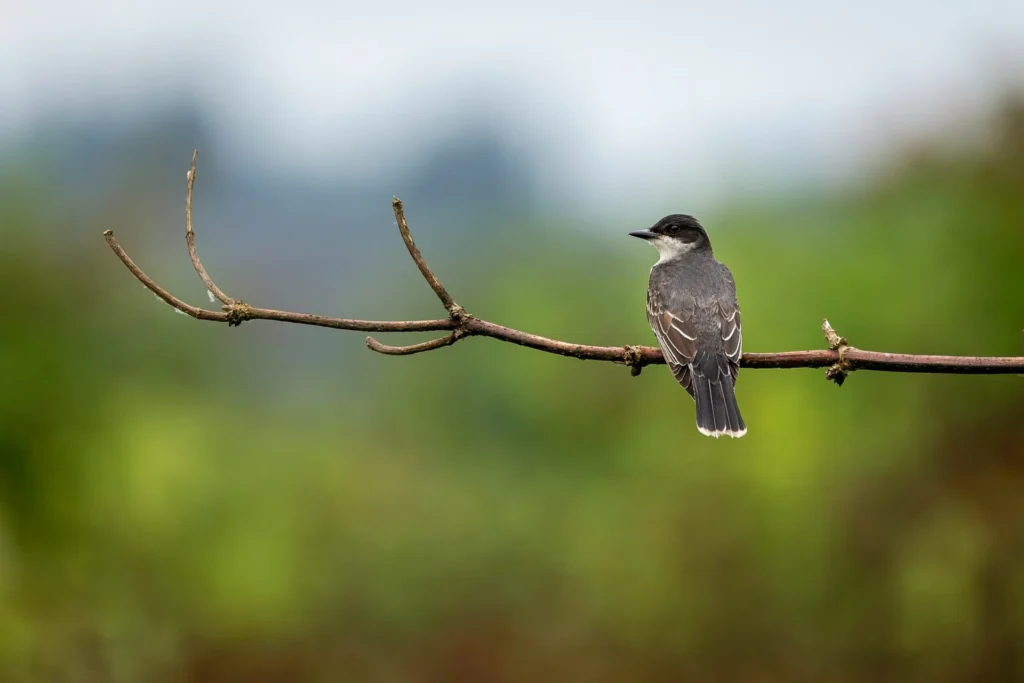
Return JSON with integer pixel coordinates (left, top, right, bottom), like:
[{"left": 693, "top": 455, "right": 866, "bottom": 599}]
[{"left": 0, "top": 0, "right": 1024, "bottom": 202}]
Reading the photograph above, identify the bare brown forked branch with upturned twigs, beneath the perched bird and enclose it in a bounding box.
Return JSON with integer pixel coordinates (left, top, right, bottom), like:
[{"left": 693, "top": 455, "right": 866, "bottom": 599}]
[{"left": 103, "top": 151, "right": 1024, "bottom": 385}]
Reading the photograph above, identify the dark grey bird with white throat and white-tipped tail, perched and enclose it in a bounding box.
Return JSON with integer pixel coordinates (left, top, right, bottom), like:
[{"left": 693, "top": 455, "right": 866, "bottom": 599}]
[{"left": 630, "top": 214, "right": 746, "bottom": 438}]
